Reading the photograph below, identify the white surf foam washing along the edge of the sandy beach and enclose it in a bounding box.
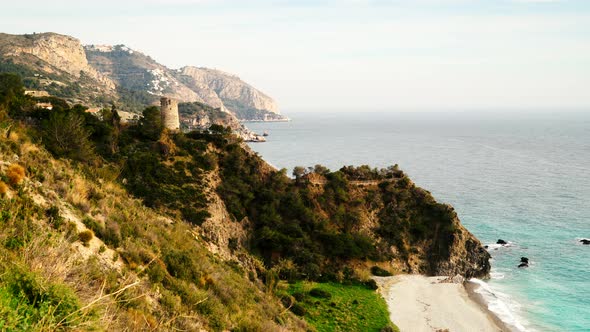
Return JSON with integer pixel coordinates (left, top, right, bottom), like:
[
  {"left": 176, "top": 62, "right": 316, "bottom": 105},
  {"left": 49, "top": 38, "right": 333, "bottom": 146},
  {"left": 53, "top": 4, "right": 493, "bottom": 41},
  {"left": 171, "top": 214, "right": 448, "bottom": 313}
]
[{"left": 469, "top": 278, "right": 527, "bottom": 331}]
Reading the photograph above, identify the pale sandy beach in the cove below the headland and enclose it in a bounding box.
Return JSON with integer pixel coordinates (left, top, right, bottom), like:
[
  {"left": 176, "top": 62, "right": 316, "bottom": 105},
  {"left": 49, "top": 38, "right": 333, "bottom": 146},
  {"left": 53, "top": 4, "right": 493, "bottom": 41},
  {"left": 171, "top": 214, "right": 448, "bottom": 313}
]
[{"left": 375, "top": 275, "right": 508, "bottom": 332}]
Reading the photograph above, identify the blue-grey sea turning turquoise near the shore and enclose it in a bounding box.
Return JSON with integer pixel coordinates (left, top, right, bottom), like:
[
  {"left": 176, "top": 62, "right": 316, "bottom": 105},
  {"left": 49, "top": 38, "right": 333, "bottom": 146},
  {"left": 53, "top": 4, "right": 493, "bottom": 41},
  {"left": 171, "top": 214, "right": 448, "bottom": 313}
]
[{"left": 246, "top": 110, "right": 590, "bottom": 331}]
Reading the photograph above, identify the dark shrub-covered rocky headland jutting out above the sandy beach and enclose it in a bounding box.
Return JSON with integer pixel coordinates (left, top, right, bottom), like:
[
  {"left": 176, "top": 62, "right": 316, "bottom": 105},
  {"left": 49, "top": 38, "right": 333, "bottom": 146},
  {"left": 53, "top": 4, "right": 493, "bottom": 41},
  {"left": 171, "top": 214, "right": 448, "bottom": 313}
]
[{"left": 218, "top": 150, "right": 490, "bottom": 279}]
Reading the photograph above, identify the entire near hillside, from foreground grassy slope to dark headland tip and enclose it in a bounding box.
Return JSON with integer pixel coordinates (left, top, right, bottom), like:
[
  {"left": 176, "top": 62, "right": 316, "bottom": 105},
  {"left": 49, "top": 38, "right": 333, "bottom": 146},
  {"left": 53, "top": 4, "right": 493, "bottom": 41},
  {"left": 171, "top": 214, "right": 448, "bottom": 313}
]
[{"left": 0, "top": 70, "right": 490, "bottom": 331}]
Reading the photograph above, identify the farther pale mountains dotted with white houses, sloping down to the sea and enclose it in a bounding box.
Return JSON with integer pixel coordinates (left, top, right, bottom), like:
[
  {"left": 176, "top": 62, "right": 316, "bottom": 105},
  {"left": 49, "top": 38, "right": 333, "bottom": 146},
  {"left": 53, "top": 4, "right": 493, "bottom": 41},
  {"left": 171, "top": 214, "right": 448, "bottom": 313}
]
[{"left": 85, "top": 45, "right": 279, "bottom": 120}]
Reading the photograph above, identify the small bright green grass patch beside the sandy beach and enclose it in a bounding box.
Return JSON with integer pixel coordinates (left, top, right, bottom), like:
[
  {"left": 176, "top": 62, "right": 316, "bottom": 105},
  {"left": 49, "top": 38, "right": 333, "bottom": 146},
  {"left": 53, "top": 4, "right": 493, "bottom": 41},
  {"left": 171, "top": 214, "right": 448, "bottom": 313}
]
[{"left": 287, "top": 282, "right": 397, "bottom": 332}]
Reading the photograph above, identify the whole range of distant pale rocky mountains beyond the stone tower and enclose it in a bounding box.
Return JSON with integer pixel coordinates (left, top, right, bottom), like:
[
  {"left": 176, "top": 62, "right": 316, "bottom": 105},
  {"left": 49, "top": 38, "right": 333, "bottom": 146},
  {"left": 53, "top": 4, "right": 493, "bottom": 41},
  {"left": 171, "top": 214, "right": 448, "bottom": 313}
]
[{"left": 0, "top": 33, "right": 285, "bottom": 120}]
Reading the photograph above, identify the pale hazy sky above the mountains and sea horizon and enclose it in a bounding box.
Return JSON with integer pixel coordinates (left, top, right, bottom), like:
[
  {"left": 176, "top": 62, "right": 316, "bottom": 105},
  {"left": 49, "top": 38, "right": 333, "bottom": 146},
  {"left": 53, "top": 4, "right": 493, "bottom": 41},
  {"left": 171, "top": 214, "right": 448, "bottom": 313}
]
[{"left": 0, "top": 0, "right": 590, "bottom": 111}]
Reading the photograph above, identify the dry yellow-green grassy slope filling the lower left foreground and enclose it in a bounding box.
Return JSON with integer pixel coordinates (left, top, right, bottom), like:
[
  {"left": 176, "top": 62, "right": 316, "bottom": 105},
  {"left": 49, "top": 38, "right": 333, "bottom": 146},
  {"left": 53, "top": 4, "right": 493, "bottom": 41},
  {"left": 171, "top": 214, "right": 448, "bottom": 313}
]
[{"left": 0, "top": 121, "right": 304, "bottom": 331}]
